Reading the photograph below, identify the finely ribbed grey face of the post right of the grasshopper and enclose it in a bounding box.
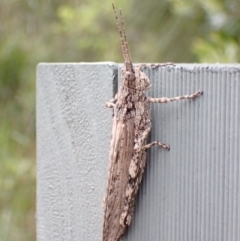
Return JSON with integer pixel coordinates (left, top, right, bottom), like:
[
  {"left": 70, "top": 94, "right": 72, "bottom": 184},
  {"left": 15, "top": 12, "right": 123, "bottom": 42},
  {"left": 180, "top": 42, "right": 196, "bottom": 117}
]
[{"left": 126, "top": 64, "right": 240, "bottom": 241}]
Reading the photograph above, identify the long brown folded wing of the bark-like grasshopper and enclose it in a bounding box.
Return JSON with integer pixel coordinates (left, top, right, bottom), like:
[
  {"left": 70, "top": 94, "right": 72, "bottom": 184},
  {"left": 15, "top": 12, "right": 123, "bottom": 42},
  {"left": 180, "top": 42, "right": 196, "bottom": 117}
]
[{"left": 103, "top": 117, "right": 134, "bottom": 241}]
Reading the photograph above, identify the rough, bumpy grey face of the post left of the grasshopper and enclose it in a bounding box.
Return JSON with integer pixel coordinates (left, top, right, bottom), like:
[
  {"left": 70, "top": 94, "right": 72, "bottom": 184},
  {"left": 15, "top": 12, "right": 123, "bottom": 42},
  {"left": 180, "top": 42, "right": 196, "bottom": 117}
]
[{"left": 37, "top": 63, "right": 117, "bottom": 241}]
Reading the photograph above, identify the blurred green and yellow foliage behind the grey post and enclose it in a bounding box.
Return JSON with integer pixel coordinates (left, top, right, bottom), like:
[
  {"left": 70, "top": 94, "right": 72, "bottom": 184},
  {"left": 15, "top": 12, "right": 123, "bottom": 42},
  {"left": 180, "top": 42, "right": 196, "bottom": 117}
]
[{"left": 0, "top": 0, "right": 240, "bottom": 241}]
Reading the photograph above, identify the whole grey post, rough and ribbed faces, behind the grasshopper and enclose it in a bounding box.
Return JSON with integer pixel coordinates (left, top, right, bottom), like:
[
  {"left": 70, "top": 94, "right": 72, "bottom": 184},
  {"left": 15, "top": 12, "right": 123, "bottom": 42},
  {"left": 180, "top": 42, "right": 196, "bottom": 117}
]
[{"left": 37, "top": 63, "right": 240, "bottom": 241}]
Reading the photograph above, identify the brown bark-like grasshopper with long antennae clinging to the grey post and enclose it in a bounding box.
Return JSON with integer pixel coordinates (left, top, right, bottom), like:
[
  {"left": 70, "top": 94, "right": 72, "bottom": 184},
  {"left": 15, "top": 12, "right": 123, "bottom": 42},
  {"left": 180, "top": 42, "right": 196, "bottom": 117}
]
[{"left": 102, "top": 5, "right": 202, "bottom": 241}]
